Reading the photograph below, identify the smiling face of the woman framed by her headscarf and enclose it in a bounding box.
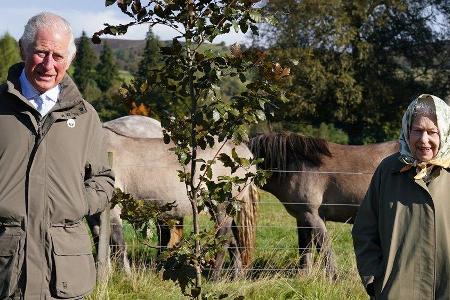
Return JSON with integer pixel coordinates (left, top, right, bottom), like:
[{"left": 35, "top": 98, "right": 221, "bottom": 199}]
[{"left": 409, "top": 116, "right": 440, "bottom": 162}]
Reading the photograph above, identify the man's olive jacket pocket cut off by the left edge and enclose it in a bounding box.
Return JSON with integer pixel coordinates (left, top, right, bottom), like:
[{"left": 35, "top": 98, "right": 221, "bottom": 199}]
[{"left": 0, "top": 227, "right": 24, "bottom": 299}]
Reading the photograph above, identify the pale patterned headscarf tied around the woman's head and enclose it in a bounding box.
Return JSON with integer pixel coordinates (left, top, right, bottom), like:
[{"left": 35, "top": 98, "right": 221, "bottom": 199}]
[{"left": 400, "top": 94, "right": 450, "bottom": 179}]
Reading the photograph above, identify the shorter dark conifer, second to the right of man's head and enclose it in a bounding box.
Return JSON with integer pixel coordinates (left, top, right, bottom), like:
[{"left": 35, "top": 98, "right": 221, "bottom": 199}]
[{"left": 95, "top": 42, "right": 119, "bottom": 92}]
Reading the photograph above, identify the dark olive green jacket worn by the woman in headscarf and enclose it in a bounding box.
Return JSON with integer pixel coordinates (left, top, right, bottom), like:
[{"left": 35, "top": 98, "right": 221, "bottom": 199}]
[{"left": 352, "top": 153, "right": 450, "bottom": 300}]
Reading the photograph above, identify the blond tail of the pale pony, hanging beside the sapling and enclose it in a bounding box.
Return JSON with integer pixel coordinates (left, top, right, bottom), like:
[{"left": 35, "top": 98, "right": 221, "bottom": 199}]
[{"left": 237, "top": 183, "right": 259, "bottom": 268}]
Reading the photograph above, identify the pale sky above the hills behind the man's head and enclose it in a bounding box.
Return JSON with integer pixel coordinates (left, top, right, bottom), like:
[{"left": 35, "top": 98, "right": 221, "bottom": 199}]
[{"left": 0, "top": 0, "right": 245, "bottom": 44}]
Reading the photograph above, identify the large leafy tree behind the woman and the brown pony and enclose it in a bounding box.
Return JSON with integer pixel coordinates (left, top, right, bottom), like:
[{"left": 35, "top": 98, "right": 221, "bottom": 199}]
[{"left": 258, "top": 0, "right": 450, "bottom": 143}]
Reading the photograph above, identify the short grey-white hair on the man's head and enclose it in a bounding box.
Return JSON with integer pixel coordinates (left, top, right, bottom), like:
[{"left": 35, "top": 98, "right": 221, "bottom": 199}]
[{"left": 20, "top": 12, "right": 77, "bottom": 63}]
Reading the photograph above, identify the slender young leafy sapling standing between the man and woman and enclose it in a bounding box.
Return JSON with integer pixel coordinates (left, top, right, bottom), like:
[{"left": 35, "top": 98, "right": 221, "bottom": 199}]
[{"left": 93, "top": 0, "right": 289, "bottom": 299}]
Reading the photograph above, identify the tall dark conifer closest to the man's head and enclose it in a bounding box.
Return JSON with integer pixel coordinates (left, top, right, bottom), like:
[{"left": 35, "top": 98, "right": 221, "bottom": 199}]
[{"left": 73, "top": 31, "right": 97, "bottom": 94}]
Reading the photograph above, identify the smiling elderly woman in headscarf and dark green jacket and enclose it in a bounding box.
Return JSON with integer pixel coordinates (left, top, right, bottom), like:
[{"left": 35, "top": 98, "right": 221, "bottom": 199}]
[{"left": 352, "top": 95, "right": 450, "bottom": 300}]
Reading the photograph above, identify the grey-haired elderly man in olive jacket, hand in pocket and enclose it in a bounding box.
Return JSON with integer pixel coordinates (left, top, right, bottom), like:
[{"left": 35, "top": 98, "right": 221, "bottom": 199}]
[{"left": 0, "top": 13, "right": 114, "bottom": 300}]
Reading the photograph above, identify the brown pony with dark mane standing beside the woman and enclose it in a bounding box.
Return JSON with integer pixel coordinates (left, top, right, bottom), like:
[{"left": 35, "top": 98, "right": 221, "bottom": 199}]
[{"left": 250, "top": 133, "right": 399, "bottom": 277}]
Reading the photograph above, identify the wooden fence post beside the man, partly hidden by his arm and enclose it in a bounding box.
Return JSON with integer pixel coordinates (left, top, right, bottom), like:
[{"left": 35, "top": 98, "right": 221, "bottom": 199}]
[{"left": 97, "top": 152, "right": 113, "bottom": 284}]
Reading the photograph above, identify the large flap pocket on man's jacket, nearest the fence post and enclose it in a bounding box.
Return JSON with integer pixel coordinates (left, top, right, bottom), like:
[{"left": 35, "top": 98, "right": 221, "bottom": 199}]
[{"left": 51, "top": 222, "right": 96, "bottom": 298}]
